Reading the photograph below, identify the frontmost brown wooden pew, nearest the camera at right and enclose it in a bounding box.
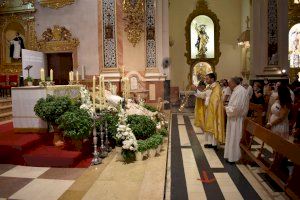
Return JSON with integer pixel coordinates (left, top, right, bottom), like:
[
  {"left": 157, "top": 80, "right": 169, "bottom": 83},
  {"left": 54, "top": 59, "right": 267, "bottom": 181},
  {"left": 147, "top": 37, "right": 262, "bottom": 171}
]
[{"left": 240, "top": 118, "right": 300, "bottom": 199}]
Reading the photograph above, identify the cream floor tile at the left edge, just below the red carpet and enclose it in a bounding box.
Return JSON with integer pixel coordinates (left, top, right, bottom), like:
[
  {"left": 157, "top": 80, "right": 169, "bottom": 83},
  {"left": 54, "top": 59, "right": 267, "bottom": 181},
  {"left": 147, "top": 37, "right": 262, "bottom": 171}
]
[{"left": 0, "top": 166, "right": 49, "bottom": 178}]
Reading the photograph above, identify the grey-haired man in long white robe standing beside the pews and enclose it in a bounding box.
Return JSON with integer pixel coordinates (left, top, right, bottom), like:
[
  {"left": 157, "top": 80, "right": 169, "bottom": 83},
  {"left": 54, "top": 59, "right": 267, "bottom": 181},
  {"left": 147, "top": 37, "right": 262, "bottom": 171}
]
[{"left": 224, "top": 77, "right": 249, "bottom": 163}]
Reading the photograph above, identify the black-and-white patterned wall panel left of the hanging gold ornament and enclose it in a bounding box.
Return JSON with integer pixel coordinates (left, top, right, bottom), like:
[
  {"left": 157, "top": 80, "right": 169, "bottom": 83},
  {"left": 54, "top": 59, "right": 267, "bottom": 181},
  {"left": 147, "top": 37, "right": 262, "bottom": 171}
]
[{"left": 102, "top": 0, "right": 117, "bottom": 68}]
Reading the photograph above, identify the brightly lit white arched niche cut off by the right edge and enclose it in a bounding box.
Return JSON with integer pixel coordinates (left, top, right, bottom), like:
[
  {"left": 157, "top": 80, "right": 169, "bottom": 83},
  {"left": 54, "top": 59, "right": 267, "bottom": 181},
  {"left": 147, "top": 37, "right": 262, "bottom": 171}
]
[{"left": 289, "top": 23, "right": 300, "bottom": 68}]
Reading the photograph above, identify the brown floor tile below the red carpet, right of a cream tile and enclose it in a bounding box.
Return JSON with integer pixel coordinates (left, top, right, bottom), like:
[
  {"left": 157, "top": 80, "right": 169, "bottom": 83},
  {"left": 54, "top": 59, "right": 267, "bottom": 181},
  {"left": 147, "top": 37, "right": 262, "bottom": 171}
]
[{"left": 38, "top": 168, "right": 86, "bottom": 180}]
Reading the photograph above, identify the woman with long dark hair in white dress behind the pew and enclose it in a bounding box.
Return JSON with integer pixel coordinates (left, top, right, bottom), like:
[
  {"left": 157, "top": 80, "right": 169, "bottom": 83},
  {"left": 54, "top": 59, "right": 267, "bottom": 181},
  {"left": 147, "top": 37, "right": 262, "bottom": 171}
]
[{"left": 266, "top": 84, "right": 292, "bottom": 139}]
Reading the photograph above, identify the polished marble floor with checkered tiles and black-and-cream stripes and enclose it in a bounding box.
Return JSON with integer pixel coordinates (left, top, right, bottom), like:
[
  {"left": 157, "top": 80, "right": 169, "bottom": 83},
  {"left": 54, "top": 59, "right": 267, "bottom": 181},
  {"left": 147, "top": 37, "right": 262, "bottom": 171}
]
[{"left": 0, "top": 112, "right": 288, "bottom": 200}]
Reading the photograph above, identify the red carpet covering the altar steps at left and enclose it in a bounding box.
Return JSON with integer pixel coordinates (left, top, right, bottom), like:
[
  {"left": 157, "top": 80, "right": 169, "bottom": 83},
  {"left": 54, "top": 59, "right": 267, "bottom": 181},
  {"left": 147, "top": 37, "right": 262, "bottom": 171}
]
[{"left": 0, "top": 123, "right": 91, "bottom": 168}]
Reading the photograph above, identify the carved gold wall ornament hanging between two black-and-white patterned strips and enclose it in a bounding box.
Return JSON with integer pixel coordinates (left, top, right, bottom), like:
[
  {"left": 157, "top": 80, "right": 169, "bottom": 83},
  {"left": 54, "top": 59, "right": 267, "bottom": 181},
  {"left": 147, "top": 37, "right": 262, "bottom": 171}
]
[{"left": 123, "top": 0, "right": 145, "bottom": 46}]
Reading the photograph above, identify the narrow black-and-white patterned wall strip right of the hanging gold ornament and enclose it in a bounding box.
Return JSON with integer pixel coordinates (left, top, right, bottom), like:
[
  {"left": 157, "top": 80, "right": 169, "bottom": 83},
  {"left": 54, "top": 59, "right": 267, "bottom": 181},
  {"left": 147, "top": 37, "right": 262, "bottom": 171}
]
[{"left": 146, "top": 0, "right": 156, "bottom": 67}]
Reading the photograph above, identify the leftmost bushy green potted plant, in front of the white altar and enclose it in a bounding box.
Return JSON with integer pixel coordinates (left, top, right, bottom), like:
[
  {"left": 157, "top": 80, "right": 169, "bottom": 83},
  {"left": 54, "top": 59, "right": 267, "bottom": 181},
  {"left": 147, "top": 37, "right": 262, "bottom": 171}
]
[{"left": 34, "top": 95, "right": 76, "bottom": 147}]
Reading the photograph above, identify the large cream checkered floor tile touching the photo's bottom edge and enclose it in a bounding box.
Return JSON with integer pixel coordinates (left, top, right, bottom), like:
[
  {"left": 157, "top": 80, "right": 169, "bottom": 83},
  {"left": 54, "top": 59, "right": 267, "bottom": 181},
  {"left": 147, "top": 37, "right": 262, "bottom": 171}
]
[{"left": 10, "top": 179, "right": 74, "bottom": 200}]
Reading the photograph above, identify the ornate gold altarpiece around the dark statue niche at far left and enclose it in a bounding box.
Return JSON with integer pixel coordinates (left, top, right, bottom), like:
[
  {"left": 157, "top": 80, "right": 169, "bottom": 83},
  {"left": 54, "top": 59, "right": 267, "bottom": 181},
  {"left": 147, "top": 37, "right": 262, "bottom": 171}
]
[{"left": 0, "top": 0, "right": 36, "bottom": 74}]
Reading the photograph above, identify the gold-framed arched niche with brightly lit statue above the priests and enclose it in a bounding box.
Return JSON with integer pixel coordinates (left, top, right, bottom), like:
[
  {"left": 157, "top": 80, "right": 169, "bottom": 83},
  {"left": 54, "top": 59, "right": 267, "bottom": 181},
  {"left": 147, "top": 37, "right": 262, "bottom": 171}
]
[{"left": 185, "top": 0, "right": 221, "bottom": 83}]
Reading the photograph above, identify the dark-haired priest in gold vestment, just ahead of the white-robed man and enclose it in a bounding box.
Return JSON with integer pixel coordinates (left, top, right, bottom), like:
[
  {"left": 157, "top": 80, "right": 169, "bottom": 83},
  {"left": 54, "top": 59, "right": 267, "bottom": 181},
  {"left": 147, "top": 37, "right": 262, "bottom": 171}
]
[{"left": 195, "top": 73, "right": 225, "bottom": 148}]
